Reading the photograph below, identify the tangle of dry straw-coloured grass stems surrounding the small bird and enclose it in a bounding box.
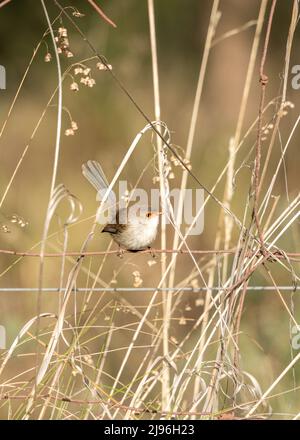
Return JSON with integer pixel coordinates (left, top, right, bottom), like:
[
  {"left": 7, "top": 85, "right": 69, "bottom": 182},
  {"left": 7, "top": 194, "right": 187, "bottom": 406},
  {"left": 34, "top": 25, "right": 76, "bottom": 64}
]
[{"left": 0, "top": 0, "right": 300, "bottom": 420}]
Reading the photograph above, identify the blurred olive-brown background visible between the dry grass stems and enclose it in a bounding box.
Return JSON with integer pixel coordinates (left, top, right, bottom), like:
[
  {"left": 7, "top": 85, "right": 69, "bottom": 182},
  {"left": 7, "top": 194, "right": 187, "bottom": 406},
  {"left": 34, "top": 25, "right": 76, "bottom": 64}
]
[{"left": 0, "top": 0, "right": 300, "bottom": 420}]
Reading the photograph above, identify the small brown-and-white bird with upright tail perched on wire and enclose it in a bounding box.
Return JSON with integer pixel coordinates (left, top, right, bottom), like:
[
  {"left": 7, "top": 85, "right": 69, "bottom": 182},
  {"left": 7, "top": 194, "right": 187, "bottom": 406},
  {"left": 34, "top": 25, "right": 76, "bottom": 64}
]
[{"left": 82, "top": 160, "right": 161, "bottom": 252}]
